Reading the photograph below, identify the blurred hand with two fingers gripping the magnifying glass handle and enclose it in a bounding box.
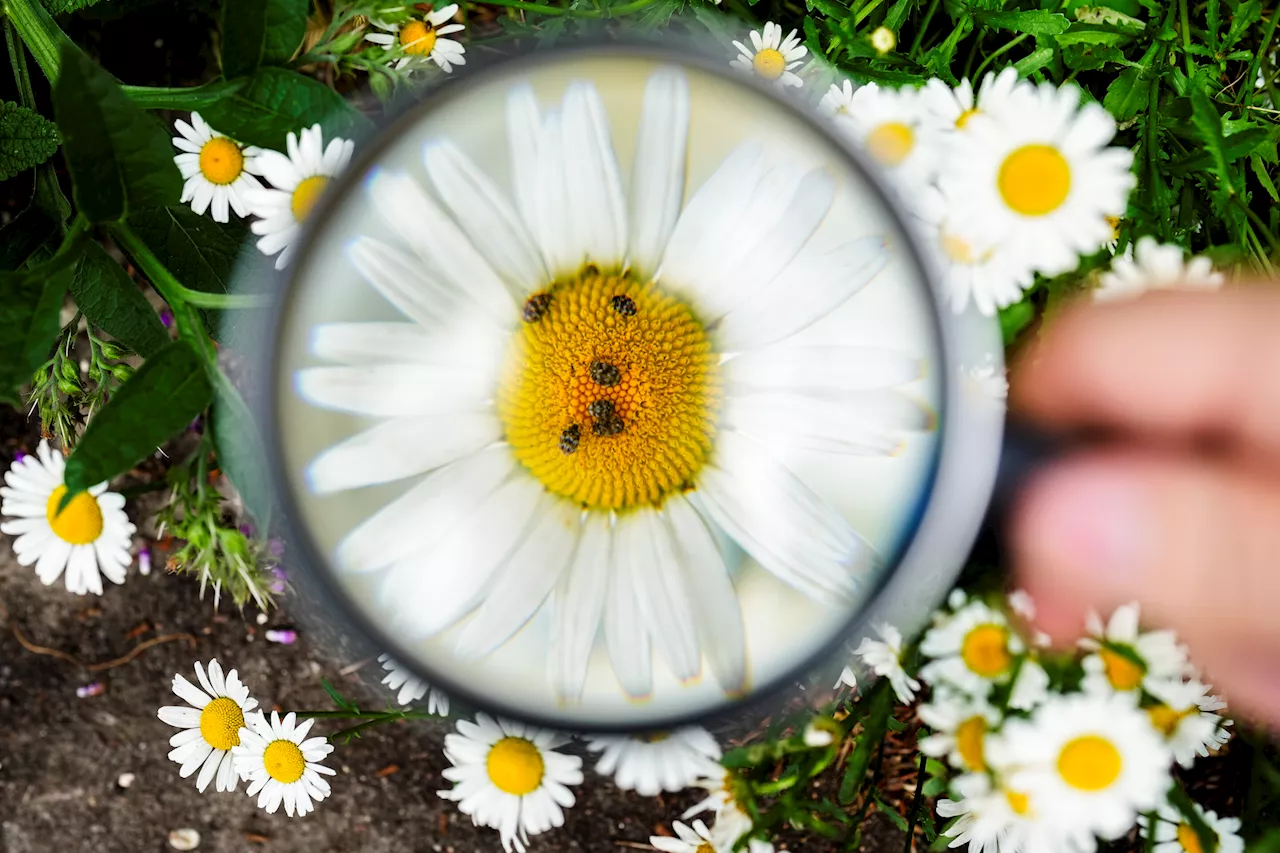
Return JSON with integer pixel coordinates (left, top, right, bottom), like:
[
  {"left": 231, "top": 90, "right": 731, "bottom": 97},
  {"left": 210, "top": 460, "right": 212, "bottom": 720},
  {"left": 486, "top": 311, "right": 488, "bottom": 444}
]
[{"left": 1011, "top": 287, "right": 1280, "bottom": 727}]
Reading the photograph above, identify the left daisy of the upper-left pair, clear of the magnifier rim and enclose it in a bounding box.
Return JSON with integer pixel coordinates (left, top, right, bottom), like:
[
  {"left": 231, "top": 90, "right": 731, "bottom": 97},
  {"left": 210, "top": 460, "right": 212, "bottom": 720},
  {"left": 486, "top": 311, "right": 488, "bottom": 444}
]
[{"left": 173, "top": 113, "right": 262, "bottom": 222}]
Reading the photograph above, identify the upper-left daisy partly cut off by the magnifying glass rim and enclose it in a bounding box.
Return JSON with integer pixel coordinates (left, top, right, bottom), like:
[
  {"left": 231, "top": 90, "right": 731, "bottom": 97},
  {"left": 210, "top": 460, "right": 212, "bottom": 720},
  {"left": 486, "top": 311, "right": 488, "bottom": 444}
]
[{"left": 244, "top": 124, "right": 355, "bottom": 269}]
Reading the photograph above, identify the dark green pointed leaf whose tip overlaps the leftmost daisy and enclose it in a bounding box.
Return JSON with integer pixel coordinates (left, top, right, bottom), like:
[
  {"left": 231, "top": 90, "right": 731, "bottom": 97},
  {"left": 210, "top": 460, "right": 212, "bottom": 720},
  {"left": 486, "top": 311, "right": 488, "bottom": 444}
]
[{"left": 65, "top": 341, "right": 212, "bottom": 494}]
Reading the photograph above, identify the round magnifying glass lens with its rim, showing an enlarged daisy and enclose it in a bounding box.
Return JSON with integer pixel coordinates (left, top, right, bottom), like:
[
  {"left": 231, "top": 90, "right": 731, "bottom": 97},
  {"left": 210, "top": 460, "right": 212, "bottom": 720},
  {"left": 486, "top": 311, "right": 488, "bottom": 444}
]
[{"left": 254, "top": 45, "right": 1002, "bottom": 731}]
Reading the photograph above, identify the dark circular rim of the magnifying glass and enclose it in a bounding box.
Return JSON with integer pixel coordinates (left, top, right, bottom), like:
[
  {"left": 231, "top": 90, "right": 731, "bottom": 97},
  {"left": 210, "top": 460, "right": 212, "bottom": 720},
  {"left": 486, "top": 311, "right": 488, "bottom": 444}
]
[{"left": 259, "top": 36, "right": 959, "bottom": 734}]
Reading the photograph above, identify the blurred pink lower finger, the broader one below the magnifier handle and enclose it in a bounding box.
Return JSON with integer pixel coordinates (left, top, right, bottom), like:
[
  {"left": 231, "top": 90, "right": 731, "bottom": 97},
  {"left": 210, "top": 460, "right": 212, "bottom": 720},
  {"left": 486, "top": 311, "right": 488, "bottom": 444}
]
[{"left": 1011, "top": 450, "right": 1280, "bottom": 722}]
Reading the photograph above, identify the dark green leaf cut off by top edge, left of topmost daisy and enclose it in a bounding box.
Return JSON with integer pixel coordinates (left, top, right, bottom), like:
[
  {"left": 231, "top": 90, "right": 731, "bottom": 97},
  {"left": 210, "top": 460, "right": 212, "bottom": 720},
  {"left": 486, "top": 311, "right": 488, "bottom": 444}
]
[{"left": 223, "top": 0, "right": 308, "bottom": 78}]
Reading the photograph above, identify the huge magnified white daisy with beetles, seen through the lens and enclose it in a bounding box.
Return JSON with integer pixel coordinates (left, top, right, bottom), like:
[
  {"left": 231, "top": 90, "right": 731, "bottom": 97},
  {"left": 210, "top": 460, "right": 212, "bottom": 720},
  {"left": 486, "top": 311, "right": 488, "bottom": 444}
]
[{"left": 297, "top": 70, "right": 911, "bottom": 701}]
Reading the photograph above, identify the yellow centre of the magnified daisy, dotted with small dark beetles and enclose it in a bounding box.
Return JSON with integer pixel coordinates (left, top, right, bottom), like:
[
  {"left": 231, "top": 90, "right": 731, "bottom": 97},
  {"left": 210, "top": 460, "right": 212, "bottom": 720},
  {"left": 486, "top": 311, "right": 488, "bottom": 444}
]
[{"left": 498, "top": 274, "right": 719, "bottom": 510}]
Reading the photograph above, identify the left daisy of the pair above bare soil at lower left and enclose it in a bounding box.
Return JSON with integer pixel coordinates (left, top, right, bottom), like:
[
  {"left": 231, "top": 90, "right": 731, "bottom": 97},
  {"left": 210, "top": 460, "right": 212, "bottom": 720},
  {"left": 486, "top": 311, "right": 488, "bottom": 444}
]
[{"left": 159, "top": 660, "right": 257, "bottom": 792}]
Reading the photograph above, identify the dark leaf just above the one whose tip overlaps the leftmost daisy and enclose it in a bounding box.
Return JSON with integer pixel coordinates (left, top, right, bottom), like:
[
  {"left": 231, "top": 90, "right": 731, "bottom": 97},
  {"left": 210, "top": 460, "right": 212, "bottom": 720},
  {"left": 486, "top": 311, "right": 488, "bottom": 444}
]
[{"left": 72, "top": 242, "right": 169, "bottom": 359}]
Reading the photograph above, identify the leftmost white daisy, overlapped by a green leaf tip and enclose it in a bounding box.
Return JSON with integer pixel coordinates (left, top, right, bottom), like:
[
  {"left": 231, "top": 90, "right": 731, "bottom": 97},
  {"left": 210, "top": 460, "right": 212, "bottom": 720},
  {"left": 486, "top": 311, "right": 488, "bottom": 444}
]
[{"left": 0, "top": 439, "right": 137, "bottom": 596}]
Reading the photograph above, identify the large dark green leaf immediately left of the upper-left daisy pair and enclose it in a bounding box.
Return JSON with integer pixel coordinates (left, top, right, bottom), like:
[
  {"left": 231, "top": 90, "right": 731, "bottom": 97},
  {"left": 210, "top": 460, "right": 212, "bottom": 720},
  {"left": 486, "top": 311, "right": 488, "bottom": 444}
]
[{"left": 54, "top": 47, "right": 182, "bottom": 223}]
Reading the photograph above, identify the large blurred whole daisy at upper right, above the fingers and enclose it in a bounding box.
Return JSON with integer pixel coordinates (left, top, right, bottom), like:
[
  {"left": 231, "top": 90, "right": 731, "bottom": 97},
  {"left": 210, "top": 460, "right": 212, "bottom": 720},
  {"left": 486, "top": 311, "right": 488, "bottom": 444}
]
[{"left": 940, "top": 83, "right": 1134, "bottom": 275}]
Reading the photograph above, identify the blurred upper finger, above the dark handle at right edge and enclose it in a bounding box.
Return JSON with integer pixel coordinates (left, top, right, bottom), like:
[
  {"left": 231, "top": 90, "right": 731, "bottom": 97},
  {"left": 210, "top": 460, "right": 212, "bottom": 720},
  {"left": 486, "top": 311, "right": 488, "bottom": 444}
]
[{"left": 1011, "top": 287, "right": 1280, "bottom": 456}]
